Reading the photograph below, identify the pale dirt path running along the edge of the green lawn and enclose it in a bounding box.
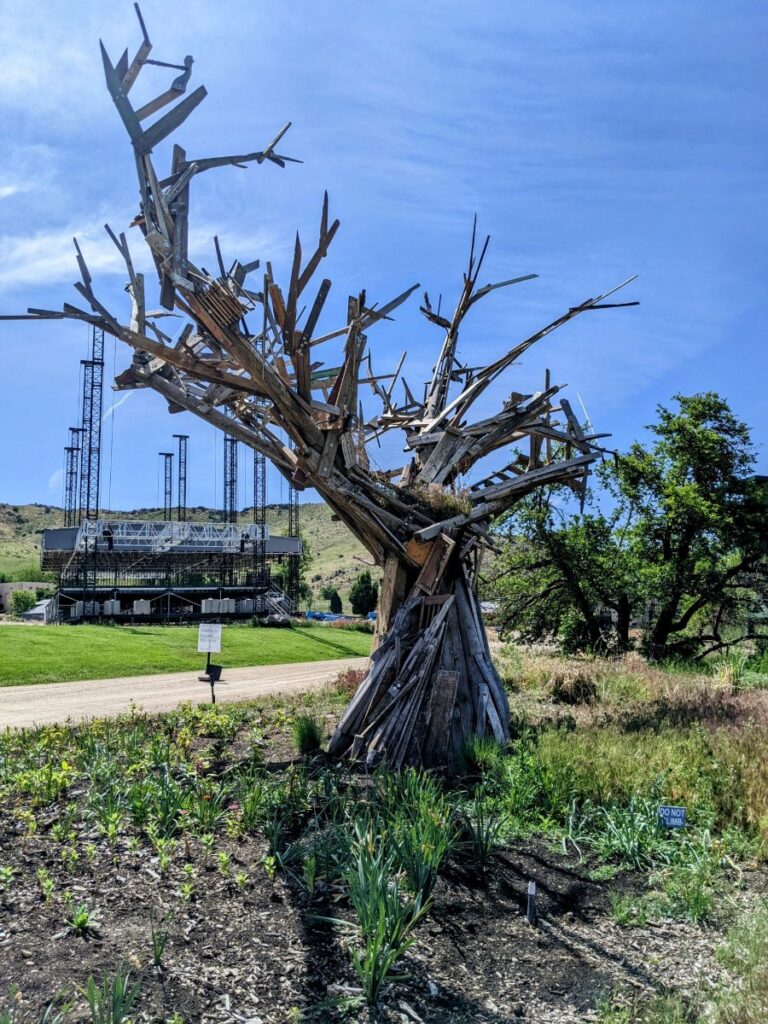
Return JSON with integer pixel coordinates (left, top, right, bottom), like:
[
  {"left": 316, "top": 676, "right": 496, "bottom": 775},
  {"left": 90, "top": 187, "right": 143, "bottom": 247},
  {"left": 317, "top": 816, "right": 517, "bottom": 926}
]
[{"left": 0, "top": 657, "right": 368, "bottom": 729}]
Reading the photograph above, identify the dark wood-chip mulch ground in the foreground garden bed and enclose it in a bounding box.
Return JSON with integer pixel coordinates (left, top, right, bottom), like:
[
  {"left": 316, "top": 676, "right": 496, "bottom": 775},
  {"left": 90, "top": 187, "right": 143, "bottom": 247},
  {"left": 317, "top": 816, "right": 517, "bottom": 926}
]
[{"left": 0, "top": 798, "right": 765, "bottom": 1024}]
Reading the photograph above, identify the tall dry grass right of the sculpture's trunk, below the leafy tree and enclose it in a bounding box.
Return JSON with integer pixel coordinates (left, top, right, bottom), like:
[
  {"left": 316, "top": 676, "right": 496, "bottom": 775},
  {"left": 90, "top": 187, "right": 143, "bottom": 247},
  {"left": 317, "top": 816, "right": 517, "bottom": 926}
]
[{"left": 497, "top": 647, "right": 768, "bottom": 856}]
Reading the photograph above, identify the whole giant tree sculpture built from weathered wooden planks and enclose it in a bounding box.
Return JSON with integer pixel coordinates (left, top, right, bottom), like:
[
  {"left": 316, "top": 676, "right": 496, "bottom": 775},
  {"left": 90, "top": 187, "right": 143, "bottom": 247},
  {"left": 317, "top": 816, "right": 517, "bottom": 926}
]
[{"left": 22, "top": 8, "right": 633, "bottom": 766}]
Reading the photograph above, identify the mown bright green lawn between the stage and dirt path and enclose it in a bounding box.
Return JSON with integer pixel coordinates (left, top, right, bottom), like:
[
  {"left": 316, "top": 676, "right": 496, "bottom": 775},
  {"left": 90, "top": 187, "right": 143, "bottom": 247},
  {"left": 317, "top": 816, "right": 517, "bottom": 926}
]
[{"left": 0, "top": 626, "right": 371, "bottom": 686}]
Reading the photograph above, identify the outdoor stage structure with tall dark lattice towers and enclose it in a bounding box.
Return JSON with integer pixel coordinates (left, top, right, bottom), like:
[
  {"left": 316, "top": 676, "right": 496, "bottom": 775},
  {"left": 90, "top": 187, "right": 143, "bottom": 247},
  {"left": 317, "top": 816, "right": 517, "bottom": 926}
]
[{"left": 41, "top": 326, "right": 301, "bottom": 623}]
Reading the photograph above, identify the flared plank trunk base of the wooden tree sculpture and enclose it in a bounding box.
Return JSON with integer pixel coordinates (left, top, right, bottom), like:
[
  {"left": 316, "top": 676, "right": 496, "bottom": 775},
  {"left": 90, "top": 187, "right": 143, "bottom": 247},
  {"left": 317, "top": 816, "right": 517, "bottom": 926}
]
[{"left": 329, "top": 556, "right": 509, "bottom": 769}]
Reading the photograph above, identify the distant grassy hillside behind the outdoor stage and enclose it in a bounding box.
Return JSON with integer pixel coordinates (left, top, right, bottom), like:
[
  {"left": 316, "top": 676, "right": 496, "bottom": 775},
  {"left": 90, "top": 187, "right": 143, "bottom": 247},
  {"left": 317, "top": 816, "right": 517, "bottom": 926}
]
[{"left": 0, "top": 502, "right": 381, "bottom": 611}]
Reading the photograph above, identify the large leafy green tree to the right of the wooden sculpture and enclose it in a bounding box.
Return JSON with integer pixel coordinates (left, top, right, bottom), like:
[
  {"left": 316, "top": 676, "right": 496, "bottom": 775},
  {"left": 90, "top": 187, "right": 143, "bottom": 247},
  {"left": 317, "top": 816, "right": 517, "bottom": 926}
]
[{"left": 496, "top": 392, "right": 768, "bottom": 658}]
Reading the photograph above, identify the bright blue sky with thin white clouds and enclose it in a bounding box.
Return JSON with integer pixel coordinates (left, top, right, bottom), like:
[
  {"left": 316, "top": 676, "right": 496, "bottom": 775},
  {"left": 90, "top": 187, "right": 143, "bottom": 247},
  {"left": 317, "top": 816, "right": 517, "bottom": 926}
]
[{"left": 0, "top": 0, "right": 768, "bottom": 508}]
